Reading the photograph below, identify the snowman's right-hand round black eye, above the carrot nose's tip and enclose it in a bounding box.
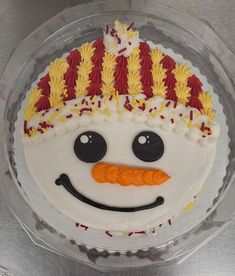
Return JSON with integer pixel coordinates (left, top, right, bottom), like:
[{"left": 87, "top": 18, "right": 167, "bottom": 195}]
[{"left": 132, "top": 131, "right": 164, "bottom": 162}]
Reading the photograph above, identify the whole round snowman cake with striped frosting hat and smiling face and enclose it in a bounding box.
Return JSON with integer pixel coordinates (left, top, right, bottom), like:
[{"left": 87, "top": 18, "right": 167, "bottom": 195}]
[{"left": 21, "top": 20, "right": 220, "bottom": 232}]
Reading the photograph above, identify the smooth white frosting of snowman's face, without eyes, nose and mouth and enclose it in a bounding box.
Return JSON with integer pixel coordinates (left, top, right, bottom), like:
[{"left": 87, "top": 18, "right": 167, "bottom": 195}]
[{"left": 24, "top": 121, "right": 216, "bottom": 231}]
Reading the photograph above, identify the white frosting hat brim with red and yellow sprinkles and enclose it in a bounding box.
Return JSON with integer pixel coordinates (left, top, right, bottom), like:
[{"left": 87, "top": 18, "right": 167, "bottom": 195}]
[{"left": 22, "top": 94, "right": 220, "bottom": 146}]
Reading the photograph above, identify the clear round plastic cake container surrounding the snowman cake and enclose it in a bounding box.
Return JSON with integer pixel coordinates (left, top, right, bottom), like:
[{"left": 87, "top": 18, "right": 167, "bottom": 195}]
[{"left": 0, "top": 0, "right": 235, "bottom": 271}]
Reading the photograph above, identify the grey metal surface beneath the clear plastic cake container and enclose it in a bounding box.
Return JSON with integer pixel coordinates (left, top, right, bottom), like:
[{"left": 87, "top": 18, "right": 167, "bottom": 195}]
[{"left": 0, "top": 0, "right": 235, "bottom": 276}]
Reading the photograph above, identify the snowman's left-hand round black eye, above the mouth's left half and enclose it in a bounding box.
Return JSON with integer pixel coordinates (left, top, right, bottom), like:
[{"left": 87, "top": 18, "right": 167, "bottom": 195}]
[{"left": 74, "top": 131, "right": 107, "bottom": 163}]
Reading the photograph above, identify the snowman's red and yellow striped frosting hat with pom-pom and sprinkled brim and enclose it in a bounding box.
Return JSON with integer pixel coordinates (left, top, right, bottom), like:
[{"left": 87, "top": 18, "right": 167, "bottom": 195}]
[{"left": 24, "top": 20, "right": 218, "bottom": 144}]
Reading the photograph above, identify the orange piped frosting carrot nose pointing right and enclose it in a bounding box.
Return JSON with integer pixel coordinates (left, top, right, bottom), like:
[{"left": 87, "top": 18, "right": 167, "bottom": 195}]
[{"left": 92, "top": 163, "right": 171, "bottom": 186}]
